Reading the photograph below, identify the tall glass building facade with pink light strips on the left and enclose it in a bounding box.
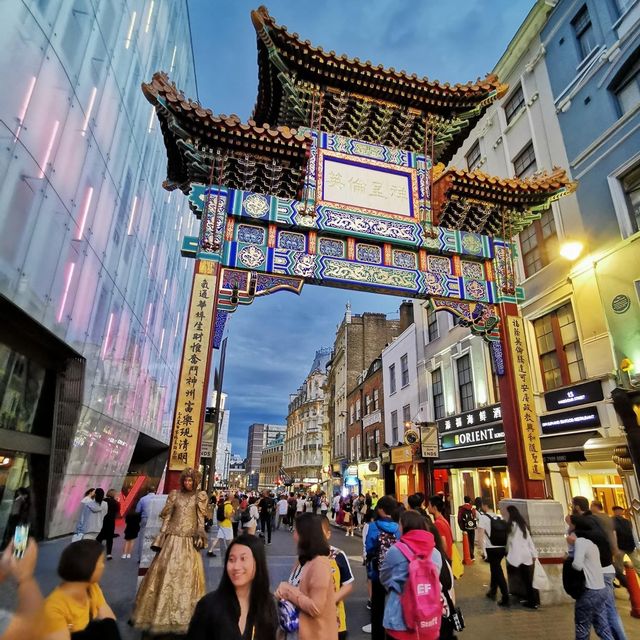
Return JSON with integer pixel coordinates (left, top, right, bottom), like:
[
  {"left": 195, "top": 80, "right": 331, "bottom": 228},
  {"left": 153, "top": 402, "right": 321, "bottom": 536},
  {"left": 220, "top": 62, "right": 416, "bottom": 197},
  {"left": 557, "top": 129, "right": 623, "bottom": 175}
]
[{"left": 0, "top": 0, "right": 197, "bottom": 537}]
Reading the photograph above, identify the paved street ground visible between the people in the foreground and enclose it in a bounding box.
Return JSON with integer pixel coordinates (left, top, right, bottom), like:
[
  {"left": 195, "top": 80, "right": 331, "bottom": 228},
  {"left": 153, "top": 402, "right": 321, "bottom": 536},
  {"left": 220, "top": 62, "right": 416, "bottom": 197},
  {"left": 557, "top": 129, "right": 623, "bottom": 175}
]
[{"left": 0, "top": 530, "right": 640, "bottom": 640}]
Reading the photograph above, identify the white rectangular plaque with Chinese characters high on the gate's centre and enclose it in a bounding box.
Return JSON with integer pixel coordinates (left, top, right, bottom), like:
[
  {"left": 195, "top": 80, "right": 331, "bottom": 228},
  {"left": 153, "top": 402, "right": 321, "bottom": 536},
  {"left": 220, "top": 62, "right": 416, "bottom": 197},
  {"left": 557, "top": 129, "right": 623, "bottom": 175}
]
[{"left": 322, "top": 156, "right": 413, "bottom": 216}]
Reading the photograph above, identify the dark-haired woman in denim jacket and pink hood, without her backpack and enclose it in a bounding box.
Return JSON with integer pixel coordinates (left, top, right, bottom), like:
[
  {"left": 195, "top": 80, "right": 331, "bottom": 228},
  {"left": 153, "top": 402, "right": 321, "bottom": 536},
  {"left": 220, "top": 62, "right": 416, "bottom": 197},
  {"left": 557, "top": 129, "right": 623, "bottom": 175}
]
[{"left": 380, "top": 509, "right": 444, "bottom": 640}]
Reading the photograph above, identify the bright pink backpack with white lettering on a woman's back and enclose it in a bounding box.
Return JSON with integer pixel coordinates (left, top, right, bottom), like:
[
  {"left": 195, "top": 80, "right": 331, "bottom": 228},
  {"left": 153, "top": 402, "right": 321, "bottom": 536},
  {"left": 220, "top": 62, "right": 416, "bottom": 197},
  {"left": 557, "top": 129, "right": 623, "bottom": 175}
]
[{"left": 396, "top": 536, "right": 442, "bottom": 640}]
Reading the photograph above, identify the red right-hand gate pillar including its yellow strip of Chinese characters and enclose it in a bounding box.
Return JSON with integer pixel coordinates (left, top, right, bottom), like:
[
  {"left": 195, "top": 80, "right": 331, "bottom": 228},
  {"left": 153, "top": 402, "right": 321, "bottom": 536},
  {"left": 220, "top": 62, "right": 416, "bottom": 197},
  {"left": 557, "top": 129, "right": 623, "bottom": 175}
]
[{"left": 498, "top": 303, "right": 545, "bottom": 499}]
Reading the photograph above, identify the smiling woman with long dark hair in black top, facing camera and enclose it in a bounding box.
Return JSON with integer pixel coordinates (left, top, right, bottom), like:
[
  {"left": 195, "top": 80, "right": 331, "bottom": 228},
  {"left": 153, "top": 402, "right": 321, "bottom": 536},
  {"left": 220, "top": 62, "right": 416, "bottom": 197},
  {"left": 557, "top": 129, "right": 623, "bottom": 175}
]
[{"left": 187, "top": 534, "right": 278, "bottom": 640}]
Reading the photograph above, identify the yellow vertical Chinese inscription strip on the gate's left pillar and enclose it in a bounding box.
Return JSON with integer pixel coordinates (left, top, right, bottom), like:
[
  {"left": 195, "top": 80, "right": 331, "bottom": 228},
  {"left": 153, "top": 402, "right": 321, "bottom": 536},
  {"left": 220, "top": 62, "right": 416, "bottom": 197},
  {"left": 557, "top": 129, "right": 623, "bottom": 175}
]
[{"left": 169, "top": 261, "right": 217, "bottom": 471}]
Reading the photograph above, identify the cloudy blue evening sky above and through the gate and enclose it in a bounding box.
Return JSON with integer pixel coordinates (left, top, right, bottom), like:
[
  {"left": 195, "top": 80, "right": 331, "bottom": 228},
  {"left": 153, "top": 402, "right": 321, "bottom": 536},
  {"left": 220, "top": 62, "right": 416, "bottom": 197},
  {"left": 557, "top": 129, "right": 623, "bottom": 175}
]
[{"left": 188, "top": 0, "right": 534, "bottom": 456}]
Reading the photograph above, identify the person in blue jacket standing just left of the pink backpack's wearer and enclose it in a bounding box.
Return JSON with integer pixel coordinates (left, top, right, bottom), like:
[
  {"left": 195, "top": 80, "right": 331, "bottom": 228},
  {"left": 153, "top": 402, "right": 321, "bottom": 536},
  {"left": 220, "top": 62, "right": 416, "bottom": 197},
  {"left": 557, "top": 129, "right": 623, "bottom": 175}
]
[{"left": 362, "top": 496, "right": 400, "bottom": 640}]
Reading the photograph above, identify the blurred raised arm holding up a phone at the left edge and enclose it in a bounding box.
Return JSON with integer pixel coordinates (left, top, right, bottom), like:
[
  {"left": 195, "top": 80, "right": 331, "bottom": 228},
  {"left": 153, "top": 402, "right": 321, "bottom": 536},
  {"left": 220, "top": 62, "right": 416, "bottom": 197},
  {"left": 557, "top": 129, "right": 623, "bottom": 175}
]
[{"left": 0, "top": 540, "right": 43, "bottom": 640}]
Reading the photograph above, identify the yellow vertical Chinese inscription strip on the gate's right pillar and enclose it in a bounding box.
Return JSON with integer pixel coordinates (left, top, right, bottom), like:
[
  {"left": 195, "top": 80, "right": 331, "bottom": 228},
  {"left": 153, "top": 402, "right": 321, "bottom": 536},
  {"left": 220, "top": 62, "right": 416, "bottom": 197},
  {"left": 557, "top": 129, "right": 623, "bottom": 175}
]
[{"left": 507, "top": 316, "right": 544, "bottom": 480}]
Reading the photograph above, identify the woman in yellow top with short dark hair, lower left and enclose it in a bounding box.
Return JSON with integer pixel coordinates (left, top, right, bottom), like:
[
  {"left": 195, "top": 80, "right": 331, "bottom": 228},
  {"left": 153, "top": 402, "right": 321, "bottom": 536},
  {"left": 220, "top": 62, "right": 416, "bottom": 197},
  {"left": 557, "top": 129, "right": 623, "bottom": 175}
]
[{"left": 42, "top": 540, "right": 120, "bottom": 640}]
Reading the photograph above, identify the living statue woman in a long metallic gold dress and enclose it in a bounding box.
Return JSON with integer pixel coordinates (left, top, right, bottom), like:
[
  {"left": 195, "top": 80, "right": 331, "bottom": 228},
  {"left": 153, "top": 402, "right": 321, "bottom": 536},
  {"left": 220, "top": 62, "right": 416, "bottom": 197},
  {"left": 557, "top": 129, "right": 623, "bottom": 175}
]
[{"left": 131, "top": 468, "right": 207, "bottom": 634}]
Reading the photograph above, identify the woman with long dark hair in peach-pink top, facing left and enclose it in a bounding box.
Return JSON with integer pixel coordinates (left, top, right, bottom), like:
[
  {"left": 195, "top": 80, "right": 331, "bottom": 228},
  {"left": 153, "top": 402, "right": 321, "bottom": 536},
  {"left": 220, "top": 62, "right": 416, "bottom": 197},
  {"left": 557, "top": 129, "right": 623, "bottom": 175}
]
[{"left": 276, "top": 513, "right": 338, "bottom": 640}]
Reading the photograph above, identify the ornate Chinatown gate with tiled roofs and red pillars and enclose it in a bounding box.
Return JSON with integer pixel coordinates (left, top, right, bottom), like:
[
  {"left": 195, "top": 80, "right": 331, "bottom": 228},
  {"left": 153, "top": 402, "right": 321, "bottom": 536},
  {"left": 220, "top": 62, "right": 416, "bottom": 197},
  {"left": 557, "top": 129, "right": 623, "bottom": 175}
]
[{"left": 142, "top": 7, "right": 575, "bottom": 560}]
